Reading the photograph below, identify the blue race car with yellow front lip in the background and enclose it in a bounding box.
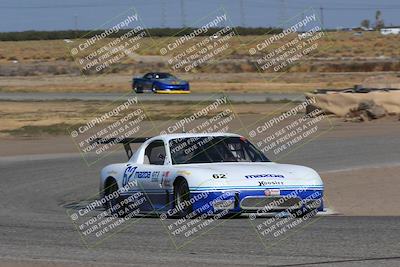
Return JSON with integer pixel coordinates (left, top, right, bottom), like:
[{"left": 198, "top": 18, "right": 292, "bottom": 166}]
[{"left": 132, "top": 72, "right": 190, "bottom": 94}]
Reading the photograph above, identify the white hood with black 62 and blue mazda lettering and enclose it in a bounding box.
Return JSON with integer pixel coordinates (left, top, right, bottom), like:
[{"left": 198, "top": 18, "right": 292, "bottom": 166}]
[{"left": 175, "top": 162, "right": 323, "bottom": 188}]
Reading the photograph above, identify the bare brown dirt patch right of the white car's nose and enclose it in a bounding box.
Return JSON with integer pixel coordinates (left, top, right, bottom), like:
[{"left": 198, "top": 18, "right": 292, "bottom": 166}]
[{"left": 321, "top": 165, "right": 400, "bottom": 216}]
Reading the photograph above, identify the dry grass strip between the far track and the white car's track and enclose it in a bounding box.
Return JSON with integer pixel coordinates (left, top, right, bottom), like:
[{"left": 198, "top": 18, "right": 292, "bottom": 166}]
[{"left": 0, "top": 101, "right": 295, "bottom": 137}]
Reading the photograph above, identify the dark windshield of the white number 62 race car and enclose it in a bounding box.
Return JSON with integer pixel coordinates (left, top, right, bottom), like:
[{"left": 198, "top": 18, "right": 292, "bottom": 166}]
[{"left": 169, "top": 136, "right": 269, "bottom": 164}]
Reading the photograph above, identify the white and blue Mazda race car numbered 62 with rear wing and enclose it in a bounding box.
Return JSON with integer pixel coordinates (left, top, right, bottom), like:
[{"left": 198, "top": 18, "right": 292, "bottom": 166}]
[{"left": 99, "top": 133, "right": 324, "bottom": 218}]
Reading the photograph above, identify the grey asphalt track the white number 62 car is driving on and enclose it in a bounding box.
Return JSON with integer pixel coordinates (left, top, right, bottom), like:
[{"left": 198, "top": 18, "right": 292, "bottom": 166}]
[{"left": 0, "top": 132, "right": 400, "bottom": 266}]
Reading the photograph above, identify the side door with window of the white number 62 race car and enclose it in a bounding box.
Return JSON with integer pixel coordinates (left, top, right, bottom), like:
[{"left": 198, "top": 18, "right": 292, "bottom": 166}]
[{"left": 138, "top": 140, "right": 168, "bottom": 210}]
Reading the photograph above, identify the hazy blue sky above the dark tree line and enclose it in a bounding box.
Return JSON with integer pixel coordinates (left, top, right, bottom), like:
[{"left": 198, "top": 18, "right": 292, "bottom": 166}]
[{"left": 0, "top": 0, "right": 400, "bottom": 32}]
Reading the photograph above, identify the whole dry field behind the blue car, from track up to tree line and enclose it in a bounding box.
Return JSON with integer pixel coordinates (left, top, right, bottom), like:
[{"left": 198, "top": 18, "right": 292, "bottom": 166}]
[{"left": 0, "top": 32, "right": 400, "bottom": 92}]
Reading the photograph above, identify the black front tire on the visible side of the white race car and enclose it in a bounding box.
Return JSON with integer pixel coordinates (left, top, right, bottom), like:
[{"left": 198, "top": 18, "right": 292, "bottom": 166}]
[{"left": 174, "top": 179, "right": 192, "bottom": 218}]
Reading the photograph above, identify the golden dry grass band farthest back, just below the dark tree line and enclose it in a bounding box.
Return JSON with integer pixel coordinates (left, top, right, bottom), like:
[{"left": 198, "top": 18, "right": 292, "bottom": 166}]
[{"left": 0, "top": 32, "right": 400, "bottom": 63}]
